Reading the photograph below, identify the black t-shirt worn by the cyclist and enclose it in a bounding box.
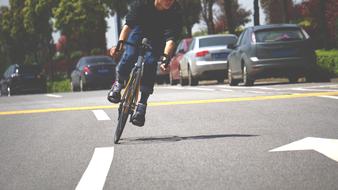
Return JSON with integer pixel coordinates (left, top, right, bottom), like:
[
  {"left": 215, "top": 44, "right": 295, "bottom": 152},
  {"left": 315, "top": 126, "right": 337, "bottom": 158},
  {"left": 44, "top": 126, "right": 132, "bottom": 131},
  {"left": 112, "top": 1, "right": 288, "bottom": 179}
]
[{"left": 126, "top": 0, "right": 182, "bottom": 42}]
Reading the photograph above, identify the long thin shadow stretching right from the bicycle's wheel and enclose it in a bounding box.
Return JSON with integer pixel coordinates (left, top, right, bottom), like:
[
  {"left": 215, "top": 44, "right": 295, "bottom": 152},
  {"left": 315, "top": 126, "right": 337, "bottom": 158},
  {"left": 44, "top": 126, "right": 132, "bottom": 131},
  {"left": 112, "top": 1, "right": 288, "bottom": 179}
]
[{"left": 119, "top": 134, "right": 259, "bottom": 145}]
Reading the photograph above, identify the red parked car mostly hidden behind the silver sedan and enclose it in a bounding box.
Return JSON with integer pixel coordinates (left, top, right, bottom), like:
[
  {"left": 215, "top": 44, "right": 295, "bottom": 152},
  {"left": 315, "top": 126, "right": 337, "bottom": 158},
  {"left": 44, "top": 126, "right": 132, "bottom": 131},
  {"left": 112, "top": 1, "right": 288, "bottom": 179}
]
[{"left": 169, "top": 38, "right": 192, "bottom": 85}]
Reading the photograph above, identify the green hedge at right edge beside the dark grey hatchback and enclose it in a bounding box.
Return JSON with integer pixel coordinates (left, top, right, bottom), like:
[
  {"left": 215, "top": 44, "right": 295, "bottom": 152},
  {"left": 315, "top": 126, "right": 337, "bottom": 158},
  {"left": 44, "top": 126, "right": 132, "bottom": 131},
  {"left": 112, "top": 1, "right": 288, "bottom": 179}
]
[{"left": 316, "top": 50, "right": 338, "bottom": 76}]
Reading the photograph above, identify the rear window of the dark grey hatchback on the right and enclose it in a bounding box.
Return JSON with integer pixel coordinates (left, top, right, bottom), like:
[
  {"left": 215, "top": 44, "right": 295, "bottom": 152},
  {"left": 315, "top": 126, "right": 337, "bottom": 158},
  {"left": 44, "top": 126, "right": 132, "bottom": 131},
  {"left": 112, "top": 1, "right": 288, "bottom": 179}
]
[{"left": 255, "top": 28, "right": 304, "bottom": 42}]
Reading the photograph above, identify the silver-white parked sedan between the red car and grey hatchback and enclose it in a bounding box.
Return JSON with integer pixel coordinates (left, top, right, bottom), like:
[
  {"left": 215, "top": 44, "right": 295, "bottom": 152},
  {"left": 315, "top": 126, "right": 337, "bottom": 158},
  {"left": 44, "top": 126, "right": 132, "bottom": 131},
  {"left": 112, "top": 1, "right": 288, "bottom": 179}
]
[{"left": 180, "top": 34, "right": 237, "bottom": 86}]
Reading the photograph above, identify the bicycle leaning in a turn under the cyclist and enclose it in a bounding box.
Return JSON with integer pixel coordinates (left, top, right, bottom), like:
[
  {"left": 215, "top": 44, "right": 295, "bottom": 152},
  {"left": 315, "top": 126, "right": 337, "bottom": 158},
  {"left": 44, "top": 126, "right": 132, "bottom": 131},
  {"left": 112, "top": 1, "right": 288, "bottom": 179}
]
[{"left": 114, "top": 38, "right": 151, "bottom": 144}]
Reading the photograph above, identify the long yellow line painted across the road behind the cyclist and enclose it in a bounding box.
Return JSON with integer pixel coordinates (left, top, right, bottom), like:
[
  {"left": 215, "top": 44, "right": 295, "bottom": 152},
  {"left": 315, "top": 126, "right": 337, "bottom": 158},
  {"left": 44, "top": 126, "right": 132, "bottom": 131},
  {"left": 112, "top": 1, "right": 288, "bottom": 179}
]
[{"left": 0, "top": 91, "right": 338, "bottom": 116}]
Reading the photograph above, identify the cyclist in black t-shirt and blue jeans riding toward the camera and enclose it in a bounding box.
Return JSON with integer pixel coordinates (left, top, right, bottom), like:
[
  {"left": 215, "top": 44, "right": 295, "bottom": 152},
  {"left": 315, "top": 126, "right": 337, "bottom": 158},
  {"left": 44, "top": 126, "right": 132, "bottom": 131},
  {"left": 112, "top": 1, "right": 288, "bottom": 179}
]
[{"left": 108, "top": 0, "right": 182, "bottom": 127}]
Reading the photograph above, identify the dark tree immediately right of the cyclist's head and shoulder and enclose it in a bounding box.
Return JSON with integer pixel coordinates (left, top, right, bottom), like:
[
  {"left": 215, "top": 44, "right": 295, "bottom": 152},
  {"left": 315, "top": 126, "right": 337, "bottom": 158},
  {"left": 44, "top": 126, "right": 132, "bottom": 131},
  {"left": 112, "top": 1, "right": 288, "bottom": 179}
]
[{"left": 178, "top": 0, "right": 202, "bottom": 37}]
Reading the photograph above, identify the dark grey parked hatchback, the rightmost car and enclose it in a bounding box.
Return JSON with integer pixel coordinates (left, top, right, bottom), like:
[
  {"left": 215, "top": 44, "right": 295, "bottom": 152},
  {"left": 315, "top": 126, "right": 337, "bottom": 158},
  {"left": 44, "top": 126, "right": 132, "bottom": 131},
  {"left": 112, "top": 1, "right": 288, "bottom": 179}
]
[{"left": 228, "top": 24, "right": 316, "bottom": 86}]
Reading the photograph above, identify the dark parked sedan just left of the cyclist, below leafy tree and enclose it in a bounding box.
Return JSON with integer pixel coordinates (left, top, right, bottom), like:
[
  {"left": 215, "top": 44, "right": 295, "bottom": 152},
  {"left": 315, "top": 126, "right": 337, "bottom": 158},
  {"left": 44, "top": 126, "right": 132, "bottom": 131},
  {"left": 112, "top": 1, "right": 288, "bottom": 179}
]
[{"left": 71, "top": 56, "right": 116, "bottom": 91}]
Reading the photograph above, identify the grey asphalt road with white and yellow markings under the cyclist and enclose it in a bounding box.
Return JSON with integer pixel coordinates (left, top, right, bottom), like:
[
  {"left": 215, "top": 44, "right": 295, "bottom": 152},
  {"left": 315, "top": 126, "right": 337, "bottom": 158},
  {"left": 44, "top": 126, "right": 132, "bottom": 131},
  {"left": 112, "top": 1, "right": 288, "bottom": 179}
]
[{"left": 0, "top": 80, "right": 338, "bottom": 190}]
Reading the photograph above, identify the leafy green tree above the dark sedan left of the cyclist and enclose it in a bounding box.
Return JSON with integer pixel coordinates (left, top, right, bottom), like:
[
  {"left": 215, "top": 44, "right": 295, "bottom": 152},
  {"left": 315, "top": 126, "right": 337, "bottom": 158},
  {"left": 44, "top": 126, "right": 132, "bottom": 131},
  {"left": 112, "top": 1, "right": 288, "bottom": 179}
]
[{"left": 53, "top": 0, "right": 108, "bottom": 58}]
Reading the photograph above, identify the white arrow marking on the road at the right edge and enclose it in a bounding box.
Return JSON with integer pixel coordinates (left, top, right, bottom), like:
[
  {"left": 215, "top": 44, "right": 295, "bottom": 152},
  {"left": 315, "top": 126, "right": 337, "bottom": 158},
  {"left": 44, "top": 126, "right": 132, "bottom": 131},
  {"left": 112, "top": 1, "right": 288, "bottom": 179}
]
[{"left": 269, "top": 137, "right": 338, "bottom": 162}]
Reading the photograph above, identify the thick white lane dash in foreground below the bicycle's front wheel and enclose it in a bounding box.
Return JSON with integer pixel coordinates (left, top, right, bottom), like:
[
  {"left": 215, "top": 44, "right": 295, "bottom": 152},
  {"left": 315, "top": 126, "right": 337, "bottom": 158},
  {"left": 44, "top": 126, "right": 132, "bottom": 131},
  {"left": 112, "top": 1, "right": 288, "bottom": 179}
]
[{"left": 75, "top": 147, "right": 114, "bottom": 190}]
